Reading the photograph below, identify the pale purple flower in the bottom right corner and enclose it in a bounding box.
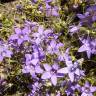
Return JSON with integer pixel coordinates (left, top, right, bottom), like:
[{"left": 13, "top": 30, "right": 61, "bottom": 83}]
[{"left": 81, "top": 81, "right": 96, "bottom": 96}]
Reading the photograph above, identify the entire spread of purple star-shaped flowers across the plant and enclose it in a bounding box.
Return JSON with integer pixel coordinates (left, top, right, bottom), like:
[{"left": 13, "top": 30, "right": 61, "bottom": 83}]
[{"left": 0, "top": 0, "right": 96, "bottom": 96}]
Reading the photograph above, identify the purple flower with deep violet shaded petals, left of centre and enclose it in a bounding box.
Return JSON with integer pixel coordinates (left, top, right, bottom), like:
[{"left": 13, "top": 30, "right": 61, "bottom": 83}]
[{"left": 25, "top": 44, "right": 45, "bottom": 65}]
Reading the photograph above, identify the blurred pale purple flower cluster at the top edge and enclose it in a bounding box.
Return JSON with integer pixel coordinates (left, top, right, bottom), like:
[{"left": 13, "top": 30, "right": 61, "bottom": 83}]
[{"left": 32, "top": 0, "right": 59, "bottom": 17}]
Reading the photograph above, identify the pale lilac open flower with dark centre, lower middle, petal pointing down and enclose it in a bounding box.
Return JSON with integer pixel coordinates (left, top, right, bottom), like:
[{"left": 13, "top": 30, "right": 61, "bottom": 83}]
[{"left": 41, "top": 64, "right": 59, "bottom": 86}]
